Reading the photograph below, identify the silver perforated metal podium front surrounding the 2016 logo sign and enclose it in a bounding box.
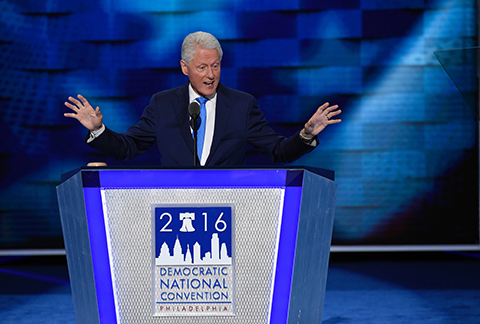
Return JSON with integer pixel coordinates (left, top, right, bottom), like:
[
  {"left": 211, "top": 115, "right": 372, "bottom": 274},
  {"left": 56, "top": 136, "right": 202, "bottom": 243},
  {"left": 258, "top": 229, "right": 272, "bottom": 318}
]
[{"left": 102, "top": 188, "right": 284, "bottom": 324}]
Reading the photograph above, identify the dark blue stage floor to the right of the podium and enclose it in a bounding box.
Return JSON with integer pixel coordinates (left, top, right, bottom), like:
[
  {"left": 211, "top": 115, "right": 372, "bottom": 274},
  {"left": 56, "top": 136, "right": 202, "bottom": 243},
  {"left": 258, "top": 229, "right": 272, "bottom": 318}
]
[{"left": 322, "top": 252, "right": 480, "bottom": 324}]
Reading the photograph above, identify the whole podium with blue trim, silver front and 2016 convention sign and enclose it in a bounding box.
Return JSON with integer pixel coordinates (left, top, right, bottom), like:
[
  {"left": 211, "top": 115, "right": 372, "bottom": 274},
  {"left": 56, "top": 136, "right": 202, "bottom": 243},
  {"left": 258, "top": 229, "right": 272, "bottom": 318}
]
[{"left": 57, "top": 167, "right": 337, "bottom": 324}]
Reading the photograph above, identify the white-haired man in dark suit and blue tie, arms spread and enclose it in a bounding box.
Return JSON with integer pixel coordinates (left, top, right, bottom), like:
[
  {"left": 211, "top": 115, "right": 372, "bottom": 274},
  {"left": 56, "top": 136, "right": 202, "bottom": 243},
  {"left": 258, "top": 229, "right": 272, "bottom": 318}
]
[{"left": 64, "top": 32, "right": 341, "bottom": 166}]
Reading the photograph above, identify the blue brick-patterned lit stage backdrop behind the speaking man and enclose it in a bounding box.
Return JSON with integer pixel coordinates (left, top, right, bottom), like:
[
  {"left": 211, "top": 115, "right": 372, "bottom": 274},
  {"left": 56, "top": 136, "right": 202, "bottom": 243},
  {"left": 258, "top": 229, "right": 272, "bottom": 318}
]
[{"left": 0, "top": 0, "right": 479, "bottom": 249}]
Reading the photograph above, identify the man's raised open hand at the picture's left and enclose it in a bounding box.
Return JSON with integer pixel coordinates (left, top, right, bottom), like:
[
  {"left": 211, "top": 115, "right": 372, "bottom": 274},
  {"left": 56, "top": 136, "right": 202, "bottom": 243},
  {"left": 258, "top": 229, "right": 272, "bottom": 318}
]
[{"left": 63, "top": 95, "right": 103, "bottom": 131}]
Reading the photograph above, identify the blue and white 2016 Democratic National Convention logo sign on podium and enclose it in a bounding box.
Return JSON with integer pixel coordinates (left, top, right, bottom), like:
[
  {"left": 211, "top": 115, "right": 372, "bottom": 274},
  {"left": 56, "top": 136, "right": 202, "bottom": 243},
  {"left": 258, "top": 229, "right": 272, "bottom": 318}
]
[{"left": 152, "top": 205, "right": 235, "bottom": 316}]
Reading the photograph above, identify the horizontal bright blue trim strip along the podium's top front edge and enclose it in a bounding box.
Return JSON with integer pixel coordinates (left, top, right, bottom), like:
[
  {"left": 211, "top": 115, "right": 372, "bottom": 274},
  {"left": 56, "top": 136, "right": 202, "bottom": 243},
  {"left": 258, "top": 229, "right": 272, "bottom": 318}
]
[{"left": 98, "top": 169, "right": 288, "bottom": 188}]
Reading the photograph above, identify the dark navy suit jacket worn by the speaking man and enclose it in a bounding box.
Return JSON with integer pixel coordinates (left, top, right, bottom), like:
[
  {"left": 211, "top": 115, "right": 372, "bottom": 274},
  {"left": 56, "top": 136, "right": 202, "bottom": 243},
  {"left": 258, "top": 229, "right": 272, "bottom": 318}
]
[{"left": 89, "top": 82, "right": 314, "bottom": 166}]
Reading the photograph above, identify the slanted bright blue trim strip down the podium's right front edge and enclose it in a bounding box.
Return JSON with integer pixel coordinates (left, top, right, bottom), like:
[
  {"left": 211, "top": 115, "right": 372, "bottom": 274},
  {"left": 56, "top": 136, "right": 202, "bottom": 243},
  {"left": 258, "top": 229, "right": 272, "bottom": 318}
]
[{"left": 270, "top": 187, "right": 302, "bottom": 324}]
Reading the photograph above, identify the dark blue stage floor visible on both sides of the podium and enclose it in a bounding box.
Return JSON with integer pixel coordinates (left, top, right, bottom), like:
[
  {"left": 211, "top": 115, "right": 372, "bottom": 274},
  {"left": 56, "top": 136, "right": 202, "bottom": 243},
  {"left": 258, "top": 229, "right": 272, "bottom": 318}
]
[{"left": 0, "top": 252, "right": 480, "bottom": 324}]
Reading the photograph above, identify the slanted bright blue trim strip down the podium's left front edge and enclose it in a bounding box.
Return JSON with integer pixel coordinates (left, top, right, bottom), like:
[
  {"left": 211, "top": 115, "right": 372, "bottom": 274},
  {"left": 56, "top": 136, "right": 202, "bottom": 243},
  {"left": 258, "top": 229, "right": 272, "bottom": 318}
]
[{"left": 83, "top": 188, "right": 117, "bottom": 323}]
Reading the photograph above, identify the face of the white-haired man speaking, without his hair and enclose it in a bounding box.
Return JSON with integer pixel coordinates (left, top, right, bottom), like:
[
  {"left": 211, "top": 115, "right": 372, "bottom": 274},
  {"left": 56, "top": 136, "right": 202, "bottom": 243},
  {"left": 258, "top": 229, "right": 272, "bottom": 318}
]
[{"left": 180, "top": 48, "right": 220, "bottom": 97}]
